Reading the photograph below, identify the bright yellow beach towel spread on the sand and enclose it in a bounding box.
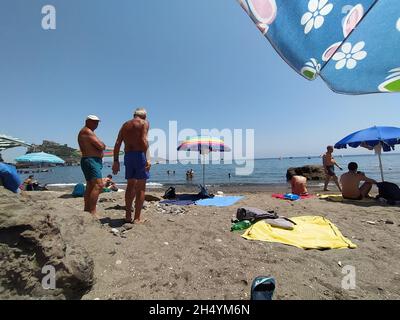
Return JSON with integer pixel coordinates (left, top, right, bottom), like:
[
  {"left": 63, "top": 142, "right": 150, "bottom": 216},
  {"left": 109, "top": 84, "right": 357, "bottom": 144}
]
[{"left": 242, "top": 216, "right": 357, "bottom": 249}]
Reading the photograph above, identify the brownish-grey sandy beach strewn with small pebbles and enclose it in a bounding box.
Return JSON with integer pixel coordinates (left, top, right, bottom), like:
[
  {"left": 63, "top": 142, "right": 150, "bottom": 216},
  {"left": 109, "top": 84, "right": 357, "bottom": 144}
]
[{"left": 0, "top": 185, "right": 400, "bottom": 299}]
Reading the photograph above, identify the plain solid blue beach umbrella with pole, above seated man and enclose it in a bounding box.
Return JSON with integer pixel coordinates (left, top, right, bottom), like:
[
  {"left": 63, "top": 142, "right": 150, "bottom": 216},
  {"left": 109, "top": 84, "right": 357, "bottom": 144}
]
[{"left": 335, "top": 126, "right": 400, "bottom": 181}]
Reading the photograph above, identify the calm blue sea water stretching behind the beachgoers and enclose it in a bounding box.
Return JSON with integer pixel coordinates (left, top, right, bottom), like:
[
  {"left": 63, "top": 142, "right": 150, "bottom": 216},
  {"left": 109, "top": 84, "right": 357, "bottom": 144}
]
[{"left": 17, "top": 153, "right": 400, "bottom": 188}]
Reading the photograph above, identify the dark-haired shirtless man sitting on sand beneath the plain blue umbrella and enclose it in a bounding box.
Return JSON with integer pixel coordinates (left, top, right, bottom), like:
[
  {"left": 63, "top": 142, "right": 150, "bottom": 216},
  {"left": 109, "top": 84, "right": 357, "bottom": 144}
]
[{"left": 340, "top": 162, "right": 377, "bottom": 200}]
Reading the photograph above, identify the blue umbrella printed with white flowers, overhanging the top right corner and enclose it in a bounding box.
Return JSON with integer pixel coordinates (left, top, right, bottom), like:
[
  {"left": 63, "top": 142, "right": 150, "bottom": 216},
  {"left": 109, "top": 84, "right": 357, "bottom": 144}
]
[{"left": 237, "top": 0, "right": 400, "bottom": 94}]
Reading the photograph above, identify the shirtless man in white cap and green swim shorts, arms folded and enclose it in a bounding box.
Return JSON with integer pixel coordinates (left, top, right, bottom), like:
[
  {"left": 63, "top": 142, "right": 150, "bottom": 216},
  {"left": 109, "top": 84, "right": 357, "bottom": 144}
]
[{"left": 78, "top": 115, "right": 106, "bottom": 218}]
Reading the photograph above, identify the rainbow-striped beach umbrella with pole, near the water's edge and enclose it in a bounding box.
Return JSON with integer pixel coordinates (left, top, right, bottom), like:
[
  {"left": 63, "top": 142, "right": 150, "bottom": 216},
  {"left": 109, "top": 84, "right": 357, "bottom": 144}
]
[{"left": 178, "top": 136, "right": 231, "bottom": 188}]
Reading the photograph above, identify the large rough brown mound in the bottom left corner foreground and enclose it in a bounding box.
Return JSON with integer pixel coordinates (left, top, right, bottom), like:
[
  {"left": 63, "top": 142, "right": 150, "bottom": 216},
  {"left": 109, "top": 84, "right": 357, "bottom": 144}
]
[{"left": 0, "top": 188, "right": 94, "bottom": 299}]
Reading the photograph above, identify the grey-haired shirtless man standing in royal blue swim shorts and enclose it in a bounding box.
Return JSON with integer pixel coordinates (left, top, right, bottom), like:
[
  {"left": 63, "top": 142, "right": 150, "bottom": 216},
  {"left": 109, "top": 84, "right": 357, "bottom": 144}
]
[{"left": 112, "top": 108, "right": 151, "bottom": 223}]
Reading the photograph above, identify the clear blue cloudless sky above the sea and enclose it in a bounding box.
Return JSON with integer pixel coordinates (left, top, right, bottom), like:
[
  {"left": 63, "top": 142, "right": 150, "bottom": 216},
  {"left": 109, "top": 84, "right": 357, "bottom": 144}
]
[{"left": 0, "top": 0, "right": 400, "bottom": 157}]
